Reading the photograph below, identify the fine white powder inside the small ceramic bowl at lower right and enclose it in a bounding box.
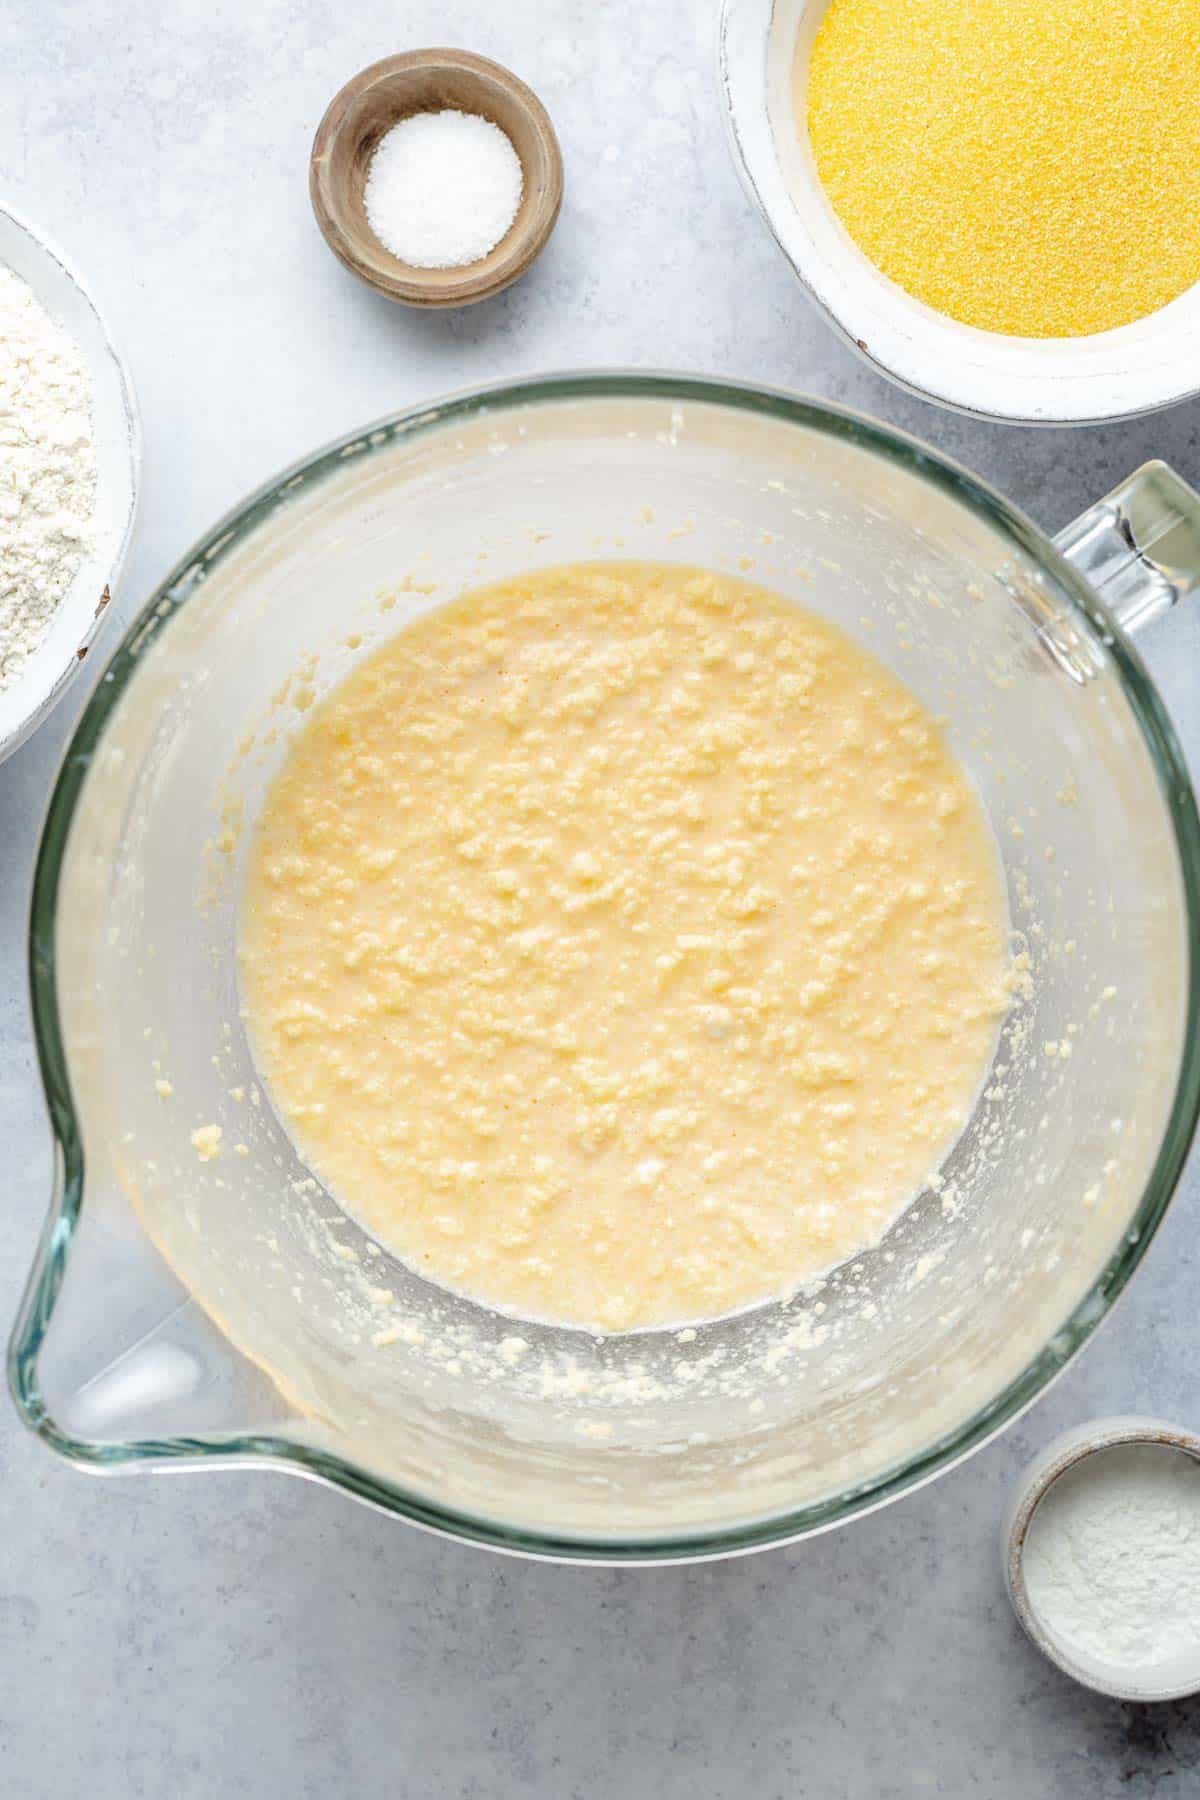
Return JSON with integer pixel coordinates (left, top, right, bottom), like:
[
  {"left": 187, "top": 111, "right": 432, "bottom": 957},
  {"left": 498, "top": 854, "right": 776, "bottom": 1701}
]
[{"left": 1025, "top": 1444, "right": 1200, "bottom": 1669}]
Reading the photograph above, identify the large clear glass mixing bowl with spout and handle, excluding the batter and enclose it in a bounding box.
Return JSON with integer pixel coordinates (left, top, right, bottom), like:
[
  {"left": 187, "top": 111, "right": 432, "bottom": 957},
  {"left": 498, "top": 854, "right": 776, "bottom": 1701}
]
[{"left": 9, "top": 374, "right": 1200, "bottom": 1561}]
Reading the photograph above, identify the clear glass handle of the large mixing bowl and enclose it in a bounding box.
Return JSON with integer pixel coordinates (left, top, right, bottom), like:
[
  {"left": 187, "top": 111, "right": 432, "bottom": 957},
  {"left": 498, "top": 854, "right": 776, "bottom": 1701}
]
[{"left": 1054, "top": 463, "right": 1200, "bottom": 632}]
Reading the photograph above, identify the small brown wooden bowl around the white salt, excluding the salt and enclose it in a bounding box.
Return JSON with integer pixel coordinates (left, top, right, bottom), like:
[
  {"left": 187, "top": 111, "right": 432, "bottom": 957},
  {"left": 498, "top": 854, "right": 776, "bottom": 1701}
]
[{"left": 308, "top": 50, "right": 563, "bottom": 306}]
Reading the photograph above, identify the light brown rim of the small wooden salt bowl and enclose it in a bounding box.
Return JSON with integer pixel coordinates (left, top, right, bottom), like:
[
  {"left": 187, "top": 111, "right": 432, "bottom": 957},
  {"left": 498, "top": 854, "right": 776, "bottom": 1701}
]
[{"left": 309, "top": 47, "right": 563, "bottom": 306}]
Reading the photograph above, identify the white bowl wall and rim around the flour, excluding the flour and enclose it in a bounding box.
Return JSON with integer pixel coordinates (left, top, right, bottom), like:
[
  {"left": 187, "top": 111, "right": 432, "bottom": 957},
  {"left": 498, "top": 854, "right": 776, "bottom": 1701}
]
[{"left": 0, "top": 207, "right": 142, "bottom": 761}]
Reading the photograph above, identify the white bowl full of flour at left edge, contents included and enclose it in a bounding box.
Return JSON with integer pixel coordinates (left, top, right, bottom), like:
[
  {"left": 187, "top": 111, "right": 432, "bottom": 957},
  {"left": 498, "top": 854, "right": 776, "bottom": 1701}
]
[{"left": 0, "top": 207, "right": 140, "bottom": 761}]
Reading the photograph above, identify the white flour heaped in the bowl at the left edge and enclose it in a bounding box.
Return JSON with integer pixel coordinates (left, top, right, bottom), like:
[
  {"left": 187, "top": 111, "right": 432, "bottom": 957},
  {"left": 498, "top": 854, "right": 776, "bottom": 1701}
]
[{"left": 0, "top": 268, "right": 95, "bottom": 691}]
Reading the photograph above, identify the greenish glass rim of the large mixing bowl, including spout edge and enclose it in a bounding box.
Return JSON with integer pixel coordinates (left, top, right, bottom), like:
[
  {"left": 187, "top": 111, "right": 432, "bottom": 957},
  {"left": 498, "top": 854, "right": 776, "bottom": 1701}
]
[{"left": 7, "top": 371, "right": 1200, "bottom": 1562}]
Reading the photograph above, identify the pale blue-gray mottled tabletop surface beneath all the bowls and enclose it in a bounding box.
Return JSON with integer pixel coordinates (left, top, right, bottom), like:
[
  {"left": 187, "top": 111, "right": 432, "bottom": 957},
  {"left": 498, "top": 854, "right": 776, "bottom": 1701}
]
[{"left": 0, "top": 0, "right": 1200, "bottom": 1800}]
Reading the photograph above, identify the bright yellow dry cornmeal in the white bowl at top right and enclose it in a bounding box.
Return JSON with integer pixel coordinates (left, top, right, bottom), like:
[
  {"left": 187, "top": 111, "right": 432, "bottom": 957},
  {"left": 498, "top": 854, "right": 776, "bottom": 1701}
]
[{"left": 797, "top": 0, "right": 1200, "bottom": 337}]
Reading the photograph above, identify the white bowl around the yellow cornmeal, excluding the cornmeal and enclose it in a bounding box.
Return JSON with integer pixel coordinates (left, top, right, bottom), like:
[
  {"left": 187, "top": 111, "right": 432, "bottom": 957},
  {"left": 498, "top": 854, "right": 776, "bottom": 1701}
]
[{"left": 720, "top": 0, "right": 1200, "bottom": 425}]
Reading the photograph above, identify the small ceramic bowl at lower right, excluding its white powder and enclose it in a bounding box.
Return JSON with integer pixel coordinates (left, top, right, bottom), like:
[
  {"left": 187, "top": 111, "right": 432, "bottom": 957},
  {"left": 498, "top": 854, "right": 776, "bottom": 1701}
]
[{"left": 1002, "top": 1415, "right": 1200, "bottom": 1701}]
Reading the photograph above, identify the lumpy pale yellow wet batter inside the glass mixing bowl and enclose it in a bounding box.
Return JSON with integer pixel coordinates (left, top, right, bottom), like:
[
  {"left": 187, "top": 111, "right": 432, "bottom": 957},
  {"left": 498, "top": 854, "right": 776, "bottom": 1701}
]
[{"left": 241, "top": 563, "right": 1007, "bottom": 1330}]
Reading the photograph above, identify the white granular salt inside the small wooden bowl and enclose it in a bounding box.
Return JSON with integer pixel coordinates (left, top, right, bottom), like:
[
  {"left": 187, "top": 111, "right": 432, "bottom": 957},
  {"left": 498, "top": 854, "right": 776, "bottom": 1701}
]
[{"left": 363, "top": 110, "right": 524, "bottom": 268}]
